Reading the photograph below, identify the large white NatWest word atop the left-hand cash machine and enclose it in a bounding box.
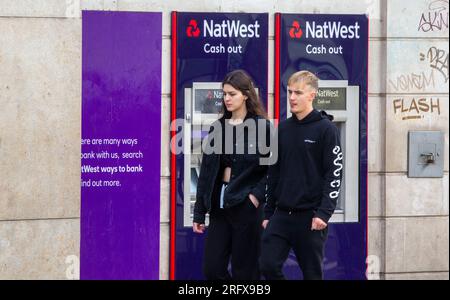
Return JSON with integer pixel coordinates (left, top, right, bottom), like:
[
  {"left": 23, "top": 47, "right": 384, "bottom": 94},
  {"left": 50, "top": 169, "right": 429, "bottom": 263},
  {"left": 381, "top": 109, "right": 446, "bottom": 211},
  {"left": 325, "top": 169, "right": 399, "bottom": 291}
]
[{"left": 203, "top": 20, "right": 260, "bottom": 38}]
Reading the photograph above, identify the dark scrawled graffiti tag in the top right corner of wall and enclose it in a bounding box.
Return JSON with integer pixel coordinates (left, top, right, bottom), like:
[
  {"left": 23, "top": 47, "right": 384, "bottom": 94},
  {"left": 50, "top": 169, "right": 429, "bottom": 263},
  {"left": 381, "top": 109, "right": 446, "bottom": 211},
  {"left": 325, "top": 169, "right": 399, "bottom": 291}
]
[{"left": 417, "top": 0, "right": 448, "bottom": 32}]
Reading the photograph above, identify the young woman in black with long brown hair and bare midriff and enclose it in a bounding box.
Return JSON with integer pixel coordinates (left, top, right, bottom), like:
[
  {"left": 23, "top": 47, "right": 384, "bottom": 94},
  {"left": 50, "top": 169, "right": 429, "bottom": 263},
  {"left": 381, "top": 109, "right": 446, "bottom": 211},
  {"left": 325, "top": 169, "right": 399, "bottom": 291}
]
[{"left": 193, "top": 70, "right": 271, "bottom": 280}]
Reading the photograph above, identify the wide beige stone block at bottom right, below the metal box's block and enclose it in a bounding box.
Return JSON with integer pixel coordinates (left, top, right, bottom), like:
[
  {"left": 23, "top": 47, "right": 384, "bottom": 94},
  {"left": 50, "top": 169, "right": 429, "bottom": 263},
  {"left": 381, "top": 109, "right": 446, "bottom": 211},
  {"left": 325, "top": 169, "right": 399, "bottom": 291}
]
[{"left": 386, "top": 216, "right": 449, "bottom": 273}]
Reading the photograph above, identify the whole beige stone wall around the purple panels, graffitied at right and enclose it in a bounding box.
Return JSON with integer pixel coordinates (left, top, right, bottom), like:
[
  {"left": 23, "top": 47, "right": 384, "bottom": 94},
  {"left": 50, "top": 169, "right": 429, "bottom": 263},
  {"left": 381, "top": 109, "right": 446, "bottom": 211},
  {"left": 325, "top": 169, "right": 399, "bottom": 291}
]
[{"left": 0, "top": 0, "right": 449, "bottom": 279}]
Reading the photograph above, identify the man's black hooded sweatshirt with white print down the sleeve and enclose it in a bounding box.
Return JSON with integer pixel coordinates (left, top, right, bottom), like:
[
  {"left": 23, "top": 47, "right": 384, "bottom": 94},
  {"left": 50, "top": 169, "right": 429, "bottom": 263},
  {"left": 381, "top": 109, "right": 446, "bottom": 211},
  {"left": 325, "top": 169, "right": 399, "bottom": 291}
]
[{"left": 264, "top": 110, "right": 343, "bottom": 222}]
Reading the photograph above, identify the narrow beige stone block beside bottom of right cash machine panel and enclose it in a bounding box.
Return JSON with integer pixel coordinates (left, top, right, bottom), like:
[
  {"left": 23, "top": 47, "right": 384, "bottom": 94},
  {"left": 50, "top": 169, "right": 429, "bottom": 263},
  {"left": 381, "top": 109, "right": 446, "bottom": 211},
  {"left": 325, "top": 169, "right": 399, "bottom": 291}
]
[{"left": 367, "top": 218, "right": 385, "bottom": 279}]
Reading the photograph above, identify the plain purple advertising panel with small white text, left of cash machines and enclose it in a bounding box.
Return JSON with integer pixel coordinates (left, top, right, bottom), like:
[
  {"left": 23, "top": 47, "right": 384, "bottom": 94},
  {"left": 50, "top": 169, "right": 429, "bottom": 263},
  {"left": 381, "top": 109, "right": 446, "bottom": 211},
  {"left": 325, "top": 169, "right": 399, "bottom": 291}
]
[{"left": 80, "top": 11, "right": 162, "bottom": 279}]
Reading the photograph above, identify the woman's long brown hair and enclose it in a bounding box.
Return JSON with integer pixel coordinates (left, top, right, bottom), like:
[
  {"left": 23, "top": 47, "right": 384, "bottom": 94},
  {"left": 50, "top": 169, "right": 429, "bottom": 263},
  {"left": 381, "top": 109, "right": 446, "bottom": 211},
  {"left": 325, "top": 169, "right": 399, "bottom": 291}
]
[{"left": 220, "top": 70, "right": 267, "bottom": 119}]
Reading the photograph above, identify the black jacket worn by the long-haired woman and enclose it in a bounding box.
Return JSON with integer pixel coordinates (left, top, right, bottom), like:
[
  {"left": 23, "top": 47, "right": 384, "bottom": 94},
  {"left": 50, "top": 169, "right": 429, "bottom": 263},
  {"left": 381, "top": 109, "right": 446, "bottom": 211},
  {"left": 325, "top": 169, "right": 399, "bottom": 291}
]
[{"left": 194, "top": 114, "right": 273, "bottom": 224}]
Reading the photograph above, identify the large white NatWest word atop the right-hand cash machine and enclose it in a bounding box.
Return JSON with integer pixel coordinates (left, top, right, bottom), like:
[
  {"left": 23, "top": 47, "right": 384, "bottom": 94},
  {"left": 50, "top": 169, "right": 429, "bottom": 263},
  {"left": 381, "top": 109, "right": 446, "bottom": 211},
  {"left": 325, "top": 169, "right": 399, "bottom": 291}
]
[{"left": 305, "top": 21, "right": 360, "bottom": 39}]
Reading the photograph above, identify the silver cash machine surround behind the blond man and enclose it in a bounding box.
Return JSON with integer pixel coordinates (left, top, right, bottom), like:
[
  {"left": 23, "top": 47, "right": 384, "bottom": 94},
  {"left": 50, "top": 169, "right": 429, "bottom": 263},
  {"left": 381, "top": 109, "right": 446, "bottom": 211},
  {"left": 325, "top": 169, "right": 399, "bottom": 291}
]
[{"left": 286, "top": 80, "right": 359, "bottom": 223}]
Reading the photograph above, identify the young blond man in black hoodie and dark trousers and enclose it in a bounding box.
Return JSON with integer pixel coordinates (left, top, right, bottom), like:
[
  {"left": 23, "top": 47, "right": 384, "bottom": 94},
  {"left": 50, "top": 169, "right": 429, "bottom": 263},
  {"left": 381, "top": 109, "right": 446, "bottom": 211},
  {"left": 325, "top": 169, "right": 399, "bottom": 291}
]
[{"left": 260, "top": 71, "right": 343, "bottom": 280}]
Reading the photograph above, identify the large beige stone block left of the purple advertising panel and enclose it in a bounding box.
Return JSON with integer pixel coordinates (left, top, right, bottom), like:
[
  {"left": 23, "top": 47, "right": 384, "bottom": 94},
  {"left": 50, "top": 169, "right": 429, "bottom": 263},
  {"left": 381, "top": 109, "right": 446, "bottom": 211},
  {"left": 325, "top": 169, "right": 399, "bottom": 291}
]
[{"left": 0, "top": 18, "right": 81, "bottom": 220}]
